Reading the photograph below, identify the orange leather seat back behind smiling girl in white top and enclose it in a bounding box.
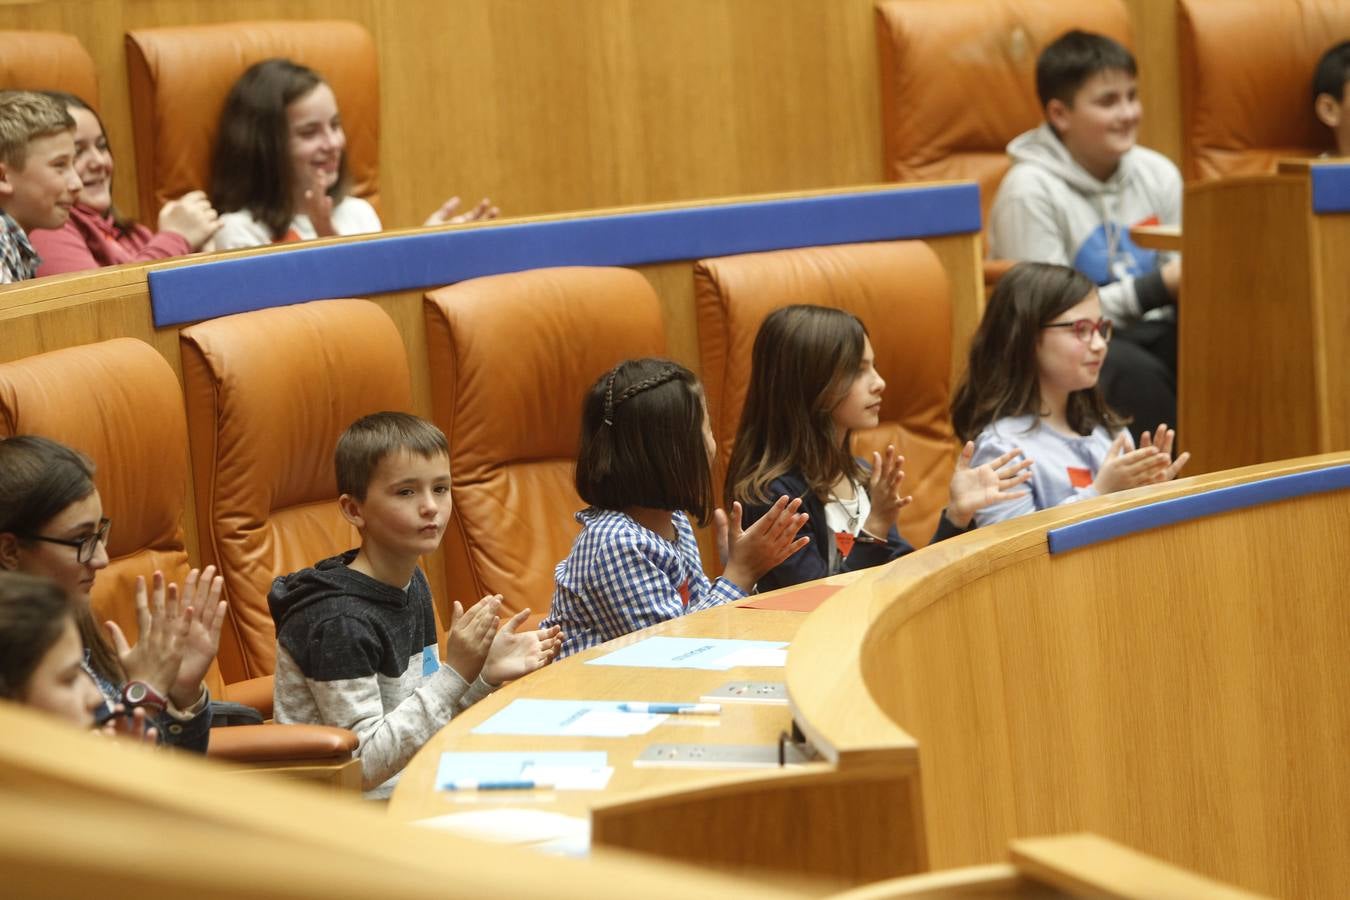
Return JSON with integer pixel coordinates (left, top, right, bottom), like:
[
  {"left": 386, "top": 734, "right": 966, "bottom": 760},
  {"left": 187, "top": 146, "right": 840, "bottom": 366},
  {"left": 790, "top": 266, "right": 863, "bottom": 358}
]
[{"left": 127, "top": 20, "right": 379, "bottom": 221}]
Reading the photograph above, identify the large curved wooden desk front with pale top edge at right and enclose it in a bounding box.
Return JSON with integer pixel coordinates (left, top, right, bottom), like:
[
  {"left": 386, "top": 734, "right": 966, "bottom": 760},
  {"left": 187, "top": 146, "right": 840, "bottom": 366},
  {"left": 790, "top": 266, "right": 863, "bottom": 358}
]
[{"left": 788, "top": 453, "right": 1350, "bottom": 897}]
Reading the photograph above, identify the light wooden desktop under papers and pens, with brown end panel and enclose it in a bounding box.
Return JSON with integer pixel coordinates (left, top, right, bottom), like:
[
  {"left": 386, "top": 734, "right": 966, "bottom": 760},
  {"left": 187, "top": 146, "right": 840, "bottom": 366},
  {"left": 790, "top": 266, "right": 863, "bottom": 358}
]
[{"left": 389, "top": 575, "right": 926, "bottom": 887}]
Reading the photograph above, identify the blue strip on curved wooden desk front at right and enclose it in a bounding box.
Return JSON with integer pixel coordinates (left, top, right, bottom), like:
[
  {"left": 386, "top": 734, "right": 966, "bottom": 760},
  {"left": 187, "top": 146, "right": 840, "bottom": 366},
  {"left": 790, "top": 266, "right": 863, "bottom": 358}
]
[{"left": 1045, "top": 466, "right": 1350, "bottom": 555}]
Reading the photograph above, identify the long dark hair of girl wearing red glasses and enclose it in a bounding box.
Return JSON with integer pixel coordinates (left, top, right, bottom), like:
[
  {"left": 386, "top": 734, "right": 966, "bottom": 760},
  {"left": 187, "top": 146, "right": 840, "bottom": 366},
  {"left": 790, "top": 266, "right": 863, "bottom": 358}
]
[{"left": 952, "top": 263, "right": 1130, "bottom": 441}]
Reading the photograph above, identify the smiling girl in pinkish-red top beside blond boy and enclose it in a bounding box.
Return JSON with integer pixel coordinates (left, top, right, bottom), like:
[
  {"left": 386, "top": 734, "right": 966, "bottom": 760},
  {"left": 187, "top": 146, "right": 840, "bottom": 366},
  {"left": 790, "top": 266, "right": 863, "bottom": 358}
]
[{"left": 28, "top": 90, "right": 220, "bottom": 275}]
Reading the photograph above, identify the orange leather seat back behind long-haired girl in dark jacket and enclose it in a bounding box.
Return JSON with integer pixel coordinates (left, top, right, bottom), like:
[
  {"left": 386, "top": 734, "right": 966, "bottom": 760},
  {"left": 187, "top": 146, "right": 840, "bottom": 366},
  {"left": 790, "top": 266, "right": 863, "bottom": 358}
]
[{"left": 694, "top": 240, "right": 956, "bottom": 546}]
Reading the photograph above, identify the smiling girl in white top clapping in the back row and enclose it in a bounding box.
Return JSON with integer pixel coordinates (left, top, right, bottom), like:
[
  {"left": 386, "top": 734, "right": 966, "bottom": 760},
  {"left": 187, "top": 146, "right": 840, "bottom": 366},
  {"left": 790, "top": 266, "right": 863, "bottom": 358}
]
[{"left": 211, "top": 59, "right": 497, "bottom": 250}]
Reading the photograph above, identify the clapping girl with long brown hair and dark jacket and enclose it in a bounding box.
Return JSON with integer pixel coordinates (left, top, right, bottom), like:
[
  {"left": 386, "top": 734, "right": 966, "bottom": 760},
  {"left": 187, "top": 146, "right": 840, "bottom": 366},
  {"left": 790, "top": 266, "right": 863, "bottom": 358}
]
[{"left": 726, "top": 305, "right": 1030, "bottom": 590}]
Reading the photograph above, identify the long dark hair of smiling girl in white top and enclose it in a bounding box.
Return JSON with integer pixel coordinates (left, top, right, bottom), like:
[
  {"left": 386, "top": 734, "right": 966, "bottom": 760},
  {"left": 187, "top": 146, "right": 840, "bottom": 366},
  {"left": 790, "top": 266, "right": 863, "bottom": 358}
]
[{"left": 211, "top": 58, "right": 351, "bottom": 240}]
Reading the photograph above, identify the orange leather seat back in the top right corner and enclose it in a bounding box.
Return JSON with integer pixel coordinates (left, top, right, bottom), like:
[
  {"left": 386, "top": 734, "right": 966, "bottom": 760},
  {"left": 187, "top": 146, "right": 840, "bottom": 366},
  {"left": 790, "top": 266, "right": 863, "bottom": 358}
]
[{"left": 1177, "top": 0, "right": 1350, "bottom": 181}]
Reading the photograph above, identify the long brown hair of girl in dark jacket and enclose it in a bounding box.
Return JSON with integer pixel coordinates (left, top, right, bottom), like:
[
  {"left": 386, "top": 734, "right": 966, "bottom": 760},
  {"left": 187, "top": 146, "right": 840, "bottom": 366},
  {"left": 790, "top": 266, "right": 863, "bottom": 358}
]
[{"left": 726, "top": 305, "right": 867, "bottom": 505}]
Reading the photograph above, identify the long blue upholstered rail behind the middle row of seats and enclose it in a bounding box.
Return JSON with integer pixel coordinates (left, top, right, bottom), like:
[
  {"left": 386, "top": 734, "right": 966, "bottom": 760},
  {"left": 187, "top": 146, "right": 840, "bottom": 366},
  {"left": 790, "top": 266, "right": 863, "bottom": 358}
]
[{"left": 149, "top": 184, "right": 980, "bottom": 328}]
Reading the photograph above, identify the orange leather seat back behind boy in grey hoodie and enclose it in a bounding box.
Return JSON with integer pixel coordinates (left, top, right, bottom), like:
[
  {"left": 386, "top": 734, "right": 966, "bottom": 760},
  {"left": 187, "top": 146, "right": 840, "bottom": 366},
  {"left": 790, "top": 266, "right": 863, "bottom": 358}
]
[{"left": 875, "top": 0, "right": 1130, "bottom": 229}]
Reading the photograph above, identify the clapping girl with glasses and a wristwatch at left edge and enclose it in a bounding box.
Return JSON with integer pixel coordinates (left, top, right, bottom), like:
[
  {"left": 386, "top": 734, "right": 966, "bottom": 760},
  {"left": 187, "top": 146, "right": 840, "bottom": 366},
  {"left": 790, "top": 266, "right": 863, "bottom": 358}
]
[{"left": 0, "top": 434, "right": 225, "bottom": 752}]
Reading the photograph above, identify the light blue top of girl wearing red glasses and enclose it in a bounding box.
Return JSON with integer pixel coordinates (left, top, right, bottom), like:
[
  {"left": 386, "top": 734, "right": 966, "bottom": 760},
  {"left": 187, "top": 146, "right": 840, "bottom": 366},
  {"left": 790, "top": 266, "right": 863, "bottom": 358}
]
[{"left": 971, "top": 416, "right": 1114, "bottom": 525}]
